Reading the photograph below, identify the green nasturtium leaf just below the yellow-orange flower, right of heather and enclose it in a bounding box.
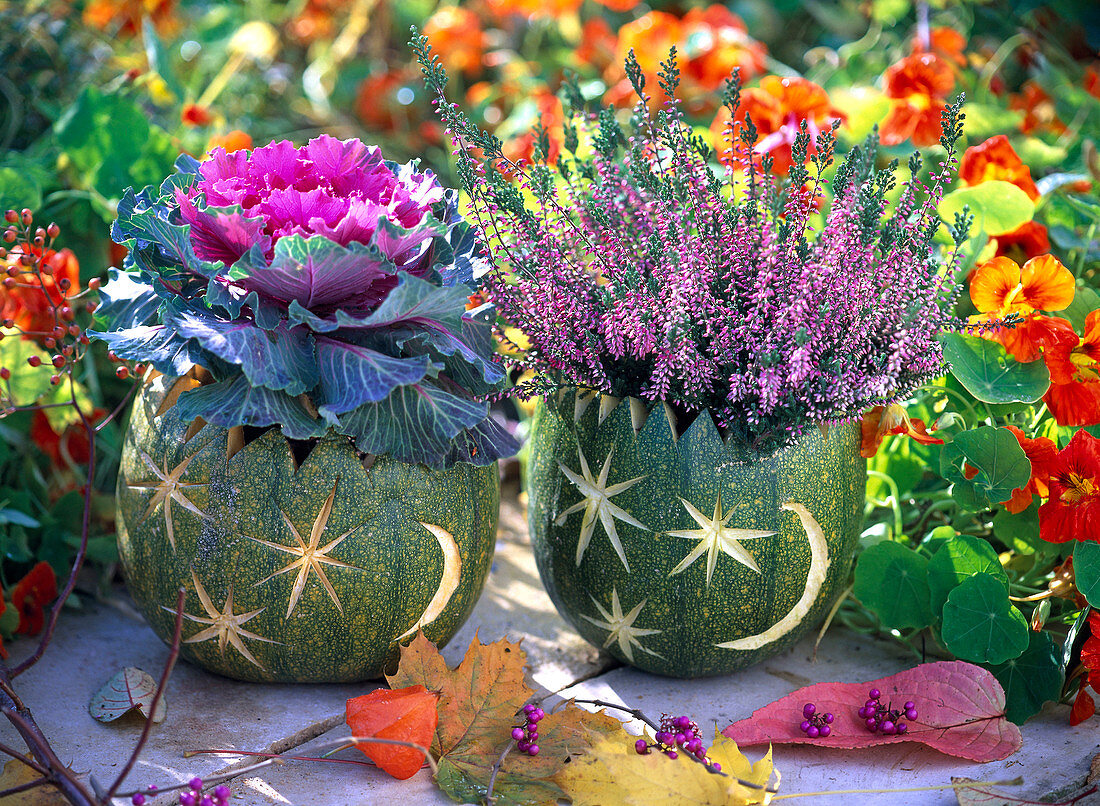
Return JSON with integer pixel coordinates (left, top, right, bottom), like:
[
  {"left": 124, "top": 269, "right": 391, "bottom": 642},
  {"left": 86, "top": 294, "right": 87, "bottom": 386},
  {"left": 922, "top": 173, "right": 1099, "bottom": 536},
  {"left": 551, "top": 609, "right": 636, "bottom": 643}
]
[{"left": 939, "top": 333, "right": 1051, "bottom": 404}]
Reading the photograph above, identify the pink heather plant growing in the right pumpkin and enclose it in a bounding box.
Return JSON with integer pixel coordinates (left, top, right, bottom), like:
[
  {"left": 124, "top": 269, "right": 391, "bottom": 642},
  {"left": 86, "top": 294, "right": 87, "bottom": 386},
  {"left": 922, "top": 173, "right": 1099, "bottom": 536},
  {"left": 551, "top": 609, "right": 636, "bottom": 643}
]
[{"left": 413, "top": 37, "right": 967, "bottom": 451}]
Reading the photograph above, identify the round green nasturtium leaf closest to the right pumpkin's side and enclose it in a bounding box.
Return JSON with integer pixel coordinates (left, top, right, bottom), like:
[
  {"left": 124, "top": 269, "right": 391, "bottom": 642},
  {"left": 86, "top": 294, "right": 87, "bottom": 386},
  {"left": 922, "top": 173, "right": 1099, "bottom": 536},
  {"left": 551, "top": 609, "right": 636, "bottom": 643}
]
[{"left": 854, "top": 541, "right": 933, "bottom": 630}]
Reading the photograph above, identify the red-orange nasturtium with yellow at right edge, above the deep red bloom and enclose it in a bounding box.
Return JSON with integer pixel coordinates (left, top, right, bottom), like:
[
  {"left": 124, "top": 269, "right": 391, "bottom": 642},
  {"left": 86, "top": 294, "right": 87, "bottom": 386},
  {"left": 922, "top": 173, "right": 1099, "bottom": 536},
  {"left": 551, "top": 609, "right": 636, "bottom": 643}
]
[{"left": 1043, "top": 311, "right": 1100, "bottom": 426}]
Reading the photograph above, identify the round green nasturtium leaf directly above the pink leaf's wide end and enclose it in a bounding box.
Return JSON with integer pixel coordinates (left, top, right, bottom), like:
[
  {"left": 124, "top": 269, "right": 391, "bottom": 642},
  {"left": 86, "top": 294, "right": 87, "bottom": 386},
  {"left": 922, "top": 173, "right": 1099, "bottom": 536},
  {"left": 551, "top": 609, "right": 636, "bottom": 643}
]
[{"left": 941, "top": 573, "right": 1029, "bottom": 664}]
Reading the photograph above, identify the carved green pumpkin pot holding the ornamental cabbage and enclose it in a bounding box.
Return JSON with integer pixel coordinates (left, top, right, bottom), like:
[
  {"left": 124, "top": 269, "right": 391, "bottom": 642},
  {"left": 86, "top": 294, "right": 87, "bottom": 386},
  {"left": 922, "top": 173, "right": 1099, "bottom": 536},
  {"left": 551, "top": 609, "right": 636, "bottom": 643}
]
[{"left": 117, "top": 376, "right": 499, "bottom": 683}]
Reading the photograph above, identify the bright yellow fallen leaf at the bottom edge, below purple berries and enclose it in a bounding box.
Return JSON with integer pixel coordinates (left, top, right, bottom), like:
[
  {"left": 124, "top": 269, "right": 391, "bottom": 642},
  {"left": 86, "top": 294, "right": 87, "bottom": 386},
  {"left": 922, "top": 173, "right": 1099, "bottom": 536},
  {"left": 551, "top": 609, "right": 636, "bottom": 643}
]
[{"left": 554, "top": 737, "right": 778, "bottom": 806}]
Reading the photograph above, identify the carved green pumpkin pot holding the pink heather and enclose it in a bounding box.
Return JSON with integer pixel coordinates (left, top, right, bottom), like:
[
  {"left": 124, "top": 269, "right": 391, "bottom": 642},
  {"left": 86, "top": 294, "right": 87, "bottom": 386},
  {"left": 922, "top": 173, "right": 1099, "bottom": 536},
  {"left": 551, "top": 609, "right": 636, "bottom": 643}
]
[{"left": 527, "top": 393, "right": 867, "bottom": 677}]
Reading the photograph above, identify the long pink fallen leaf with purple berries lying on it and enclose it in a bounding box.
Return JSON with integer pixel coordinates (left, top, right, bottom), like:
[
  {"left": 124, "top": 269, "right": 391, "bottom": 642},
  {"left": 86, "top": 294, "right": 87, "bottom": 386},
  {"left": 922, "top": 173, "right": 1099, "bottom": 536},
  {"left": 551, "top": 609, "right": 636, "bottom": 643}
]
[{"left": 722, "top": 661, "right": 1022, "bottom": 763}]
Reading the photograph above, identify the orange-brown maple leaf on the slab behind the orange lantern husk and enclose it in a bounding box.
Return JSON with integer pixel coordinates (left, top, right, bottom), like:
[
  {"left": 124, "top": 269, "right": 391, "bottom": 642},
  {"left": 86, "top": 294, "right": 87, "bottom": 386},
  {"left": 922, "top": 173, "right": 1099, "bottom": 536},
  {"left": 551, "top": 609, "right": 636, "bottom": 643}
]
[{"left": 386, "top": 633, "right": 625, "bottom": 806}]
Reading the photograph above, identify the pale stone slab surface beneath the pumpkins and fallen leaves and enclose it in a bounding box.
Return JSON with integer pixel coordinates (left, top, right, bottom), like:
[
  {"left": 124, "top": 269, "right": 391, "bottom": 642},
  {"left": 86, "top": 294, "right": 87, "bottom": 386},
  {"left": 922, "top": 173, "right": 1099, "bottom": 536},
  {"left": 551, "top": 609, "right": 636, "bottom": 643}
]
[{"left": 0, "top": 488, "right": 1100, "bottom": 806}]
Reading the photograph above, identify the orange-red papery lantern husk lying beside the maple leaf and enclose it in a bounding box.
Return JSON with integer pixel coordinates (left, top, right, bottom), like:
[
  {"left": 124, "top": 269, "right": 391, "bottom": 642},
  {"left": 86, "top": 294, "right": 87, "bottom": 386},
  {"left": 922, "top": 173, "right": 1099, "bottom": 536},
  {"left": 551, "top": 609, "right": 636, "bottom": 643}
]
[{"left": 347, "top": 686, "right": 439, "bottom": 781}]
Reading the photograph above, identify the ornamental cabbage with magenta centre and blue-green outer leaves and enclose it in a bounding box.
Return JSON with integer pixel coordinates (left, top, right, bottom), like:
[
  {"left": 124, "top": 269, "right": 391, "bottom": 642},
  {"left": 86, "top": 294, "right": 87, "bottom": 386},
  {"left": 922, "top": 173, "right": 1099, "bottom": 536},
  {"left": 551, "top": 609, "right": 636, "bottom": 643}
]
[{"left": 97, "top": 136, "right": 518, "bottom": 467}]
